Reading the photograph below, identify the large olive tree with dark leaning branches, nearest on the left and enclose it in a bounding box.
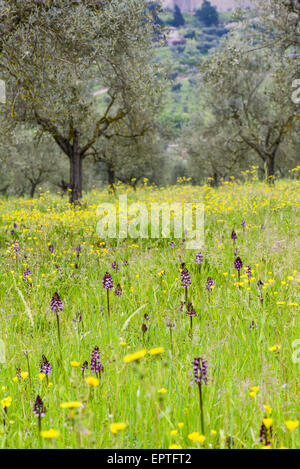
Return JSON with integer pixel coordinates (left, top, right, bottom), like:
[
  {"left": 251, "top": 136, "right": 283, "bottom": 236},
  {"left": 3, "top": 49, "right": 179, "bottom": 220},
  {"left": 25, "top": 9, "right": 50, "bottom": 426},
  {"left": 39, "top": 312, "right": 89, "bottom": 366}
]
[{"left": 0, "top": 0, "right": 161, "bottom": 203}]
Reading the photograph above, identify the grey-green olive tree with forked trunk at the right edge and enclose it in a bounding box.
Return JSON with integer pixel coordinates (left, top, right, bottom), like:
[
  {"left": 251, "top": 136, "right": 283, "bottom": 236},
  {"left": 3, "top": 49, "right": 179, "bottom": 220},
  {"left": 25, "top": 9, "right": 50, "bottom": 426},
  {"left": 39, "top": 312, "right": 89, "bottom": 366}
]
[{"left": 201, "top": 0, "right": 299, "bottom": 181}]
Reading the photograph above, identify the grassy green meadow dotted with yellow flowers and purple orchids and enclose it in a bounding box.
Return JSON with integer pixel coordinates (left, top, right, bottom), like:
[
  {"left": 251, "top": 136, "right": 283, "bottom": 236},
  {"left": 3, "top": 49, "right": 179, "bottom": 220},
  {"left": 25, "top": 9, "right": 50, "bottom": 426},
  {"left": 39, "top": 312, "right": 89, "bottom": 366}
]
[{"left": 0, "top": 179, "right": 300, "bottom": 449}]
